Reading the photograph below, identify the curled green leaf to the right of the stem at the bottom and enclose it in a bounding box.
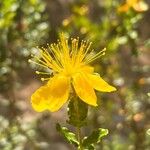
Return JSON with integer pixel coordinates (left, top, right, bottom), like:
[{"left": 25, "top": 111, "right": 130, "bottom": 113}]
[{"left": 83, "top": 128, "right": 108, "bottom": 147}]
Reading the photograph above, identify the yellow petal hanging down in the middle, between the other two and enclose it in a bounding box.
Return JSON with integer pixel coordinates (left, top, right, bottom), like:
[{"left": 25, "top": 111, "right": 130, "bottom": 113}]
[{"left": 73, "top": 73, "right": 97, "bottom": 106}]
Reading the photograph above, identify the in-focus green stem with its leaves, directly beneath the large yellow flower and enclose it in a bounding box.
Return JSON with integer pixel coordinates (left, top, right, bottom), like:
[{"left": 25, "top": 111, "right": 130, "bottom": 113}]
[{"left": 56, "top": 99, "right": 108, "bottom": 150}]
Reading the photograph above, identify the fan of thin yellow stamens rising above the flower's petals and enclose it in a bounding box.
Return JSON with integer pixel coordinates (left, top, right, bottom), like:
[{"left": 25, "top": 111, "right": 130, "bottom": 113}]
[{"left": 29, "top": 34, "right": 106, "bottom": 78}]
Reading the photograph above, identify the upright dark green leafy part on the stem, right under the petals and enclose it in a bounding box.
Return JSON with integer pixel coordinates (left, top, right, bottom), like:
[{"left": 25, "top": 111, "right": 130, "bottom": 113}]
[{"left": 67, "top": 98, "right": 88, "bottom": 127}]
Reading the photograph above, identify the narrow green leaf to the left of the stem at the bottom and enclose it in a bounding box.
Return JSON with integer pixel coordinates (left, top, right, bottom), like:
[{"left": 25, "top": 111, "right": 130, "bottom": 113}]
[{"left": 56, "top": 123, "right": 79, "bottom": 146}]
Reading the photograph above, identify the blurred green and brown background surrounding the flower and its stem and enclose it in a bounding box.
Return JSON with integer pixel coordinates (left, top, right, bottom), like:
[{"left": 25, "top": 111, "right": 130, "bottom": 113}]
[{"left": 0, "top": 0, "right": 150, "bottom": 150}]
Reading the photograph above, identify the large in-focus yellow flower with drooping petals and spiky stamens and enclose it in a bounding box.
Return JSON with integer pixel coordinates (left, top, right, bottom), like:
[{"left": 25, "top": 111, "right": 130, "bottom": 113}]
[{"left": 30, "top": 34, "right": 116, "bottom": 112}]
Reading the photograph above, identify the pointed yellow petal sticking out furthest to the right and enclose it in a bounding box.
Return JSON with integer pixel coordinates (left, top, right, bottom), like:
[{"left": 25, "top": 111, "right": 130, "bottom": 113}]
[{"left": 86, "top": 74, "right": 116, "bottom": 92}]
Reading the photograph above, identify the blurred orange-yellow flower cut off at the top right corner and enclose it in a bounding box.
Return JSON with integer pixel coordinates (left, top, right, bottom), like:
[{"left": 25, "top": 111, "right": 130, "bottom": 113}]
[{"left": 118, "top": 0, "right": 148, "bottom": 12}]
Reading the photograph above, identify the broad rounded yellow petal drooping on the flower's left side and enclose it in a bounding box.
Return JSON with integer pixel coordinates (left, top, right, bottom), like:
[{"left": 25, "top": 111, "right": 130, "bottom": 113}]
[{"left": 31, "top": 75, "right": 69, "bottom": 112}]
